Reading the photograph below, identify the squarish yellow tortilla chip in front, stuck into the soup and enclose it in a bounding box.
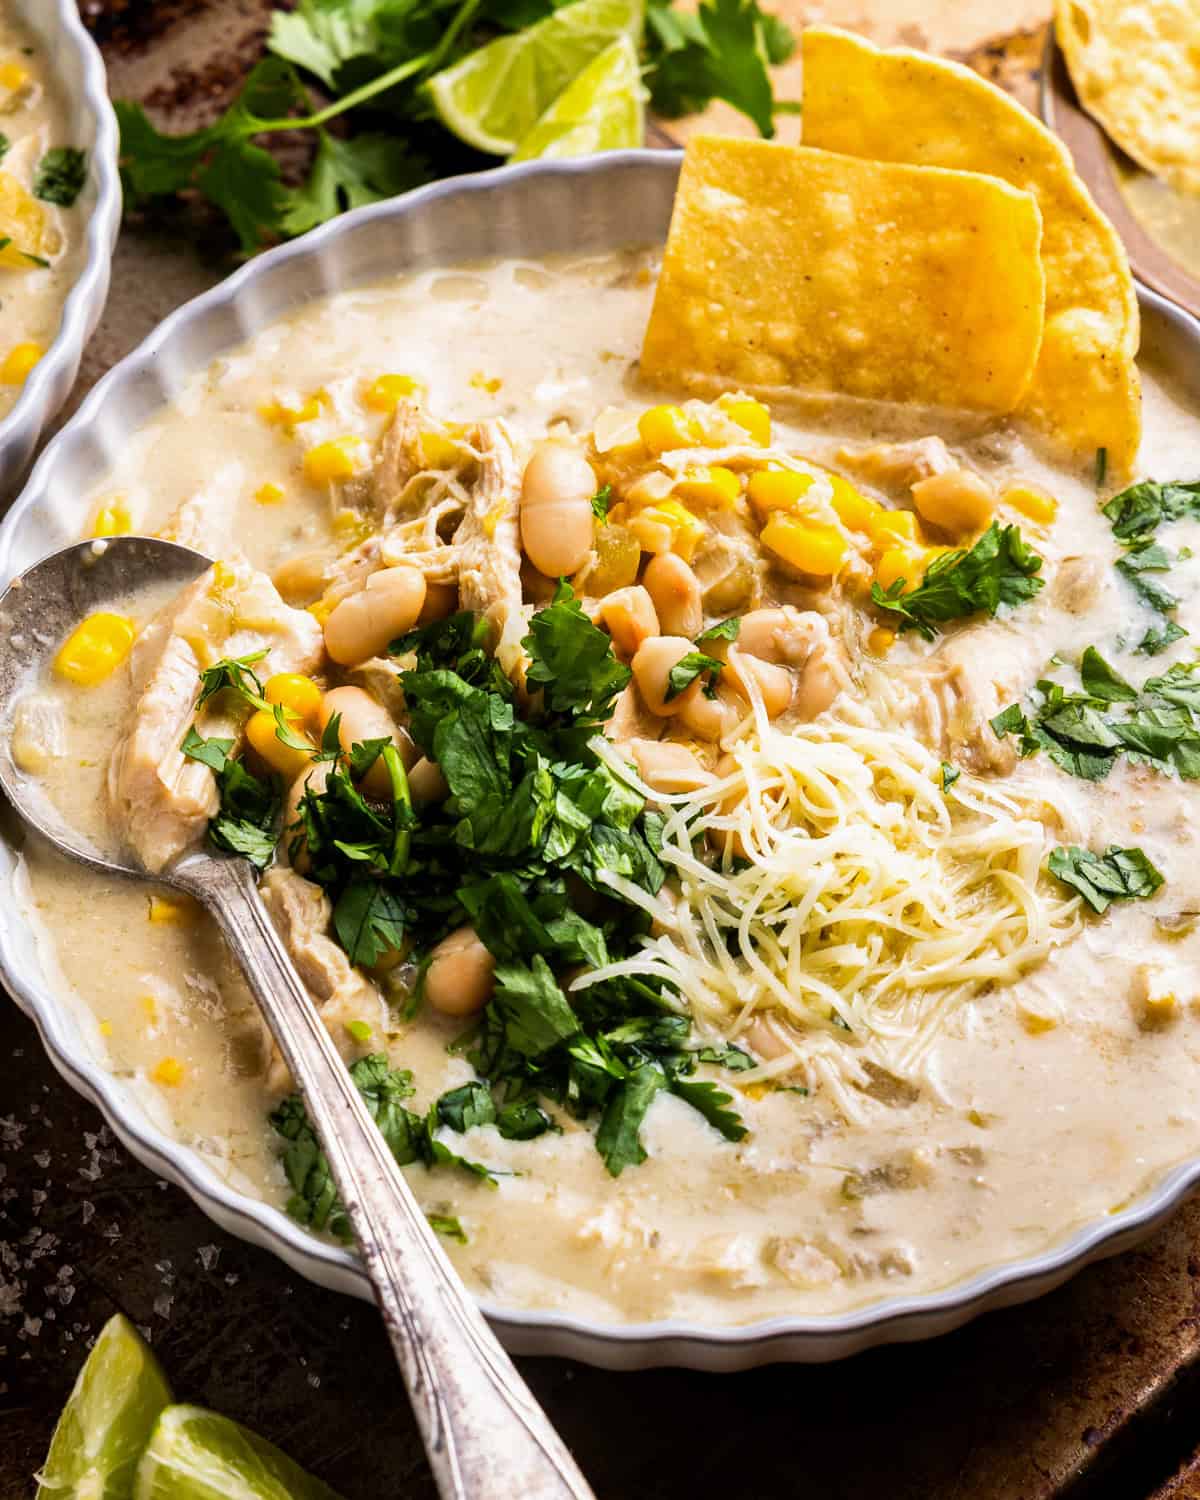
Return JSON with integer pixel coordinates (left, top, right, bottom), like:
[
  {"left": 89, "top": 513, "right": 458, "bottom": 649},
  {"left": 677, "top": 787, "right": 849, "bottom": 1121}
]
[{"left": 642, "top": 135, "right": 1044, "bottom": 413}]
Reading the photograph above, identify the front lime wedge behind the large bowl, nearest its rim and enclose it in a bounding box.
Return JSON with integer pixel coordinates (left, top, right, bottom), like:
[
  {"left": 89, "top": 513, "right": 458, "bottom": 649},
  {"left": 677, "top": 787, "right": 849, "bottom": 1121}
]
[{"left": 510, "top": 36, "right": 647, "bottom": 162}]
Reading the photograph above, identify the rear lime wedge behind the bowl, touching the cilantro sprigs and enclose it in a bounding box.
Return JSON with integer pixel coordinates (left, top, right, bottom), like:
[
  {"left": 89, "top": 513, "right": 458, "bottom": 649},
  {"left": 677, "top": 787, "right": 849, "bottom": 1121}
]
[{"left": 428, "top": 0, "right": 642, "bottom": 156}]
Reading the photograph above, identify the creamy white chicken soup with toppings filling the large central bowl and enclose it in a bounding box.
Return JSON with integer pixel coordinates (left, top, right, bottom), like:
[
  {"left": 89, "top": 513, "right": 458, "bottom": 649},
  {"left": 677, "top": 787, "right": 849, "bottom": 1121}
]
[{"left": 15, "top": 252, "right": 1200, "bottom": 1325}]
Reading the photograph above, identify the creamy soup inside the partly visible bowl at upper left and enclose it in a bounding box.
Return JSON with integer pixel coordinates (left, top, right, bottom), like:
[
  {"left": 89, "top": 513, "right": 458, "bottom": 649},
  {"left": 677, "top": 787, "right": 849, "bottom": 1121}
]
[{"left": 0, "top": 0, "right": 87, "bottom": 417}]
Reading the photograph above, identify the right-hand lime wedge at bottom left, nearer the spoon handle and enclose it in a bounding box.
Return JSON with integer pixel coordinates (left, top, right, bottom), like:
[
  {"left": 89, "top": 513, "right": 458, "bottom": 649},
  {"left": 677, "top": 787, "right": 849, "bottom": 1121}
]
[{"left": 134, "top": 1406, "right": 345, "bottom": 1500}]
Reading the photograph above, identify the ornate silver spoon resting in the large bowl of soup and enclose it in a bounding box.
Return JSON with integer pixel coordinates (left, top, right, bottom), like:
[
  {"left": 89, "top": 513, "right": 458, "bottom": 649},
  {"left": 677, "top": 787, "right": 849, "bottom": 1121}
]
[{"left": 0, "top": 537, "right": 593, "bottom": 1500}]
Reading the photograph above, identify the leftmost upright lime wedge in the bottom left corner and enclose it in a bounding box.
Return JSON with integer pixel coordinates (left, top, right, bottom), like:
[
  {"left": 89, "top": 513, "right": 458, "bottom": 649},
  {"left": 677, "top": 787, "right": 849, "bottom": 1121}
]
[{"left": 38, "top": 1313, "right": 171, "bottom": 1500}]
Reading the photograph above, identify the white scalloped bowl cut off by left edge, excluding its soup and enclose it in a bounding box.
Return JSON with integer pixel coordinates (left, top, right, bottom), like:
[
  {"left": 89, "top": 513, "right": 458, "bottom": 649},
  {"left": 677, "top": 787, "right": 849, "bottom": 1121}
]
[{"left": 0, "top": 0, "right": 122, "bottom": 498}]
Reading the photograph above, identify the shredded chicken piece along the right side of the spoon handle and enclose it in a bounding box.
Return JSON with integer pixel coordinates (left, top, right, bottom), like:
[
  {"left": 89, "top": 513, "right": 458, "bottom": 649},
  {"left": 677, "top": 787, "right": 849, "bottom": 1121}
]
[{"left": 260, "top": 866, "right": 387, "bottom": 1092}]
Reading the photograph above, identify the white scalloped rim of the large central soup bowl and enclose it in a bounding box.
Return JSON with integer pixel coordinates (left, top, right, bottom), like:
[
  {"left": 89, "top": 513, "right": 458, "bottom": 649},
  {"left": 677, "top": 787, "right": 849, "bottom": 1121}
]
[{"left": 0, "top": 150, "right": 1200, "bottom": 1370}]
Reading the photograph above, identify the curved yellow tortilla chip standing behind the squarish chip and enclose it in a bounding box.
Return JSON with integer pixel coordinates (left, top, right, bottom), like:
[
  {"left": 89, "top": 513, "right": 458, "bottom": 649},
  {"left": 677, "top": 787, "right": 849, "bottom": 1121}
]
[{"left": 803, "top": 27, "right": 1142, "bottom": 474}]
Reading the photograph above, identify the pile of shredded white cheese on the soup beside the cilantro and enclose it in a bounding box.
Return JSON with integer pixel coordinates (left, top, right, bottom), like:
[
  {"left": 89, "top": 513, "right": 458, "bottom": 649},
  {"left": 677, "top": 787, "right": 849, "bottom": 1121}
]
[{"left": 575, "top": 687, "right": 1079, "bottom": 1113}]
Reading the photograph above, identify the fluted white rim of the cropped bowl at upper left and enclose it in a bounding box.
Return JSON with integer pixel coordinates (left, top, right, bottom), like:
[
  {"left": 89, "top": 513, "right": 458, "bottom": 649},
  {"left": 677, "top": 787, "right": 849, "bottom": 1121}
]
[{"left": 0, "top": 0, "right": 122, "bottom": 483}]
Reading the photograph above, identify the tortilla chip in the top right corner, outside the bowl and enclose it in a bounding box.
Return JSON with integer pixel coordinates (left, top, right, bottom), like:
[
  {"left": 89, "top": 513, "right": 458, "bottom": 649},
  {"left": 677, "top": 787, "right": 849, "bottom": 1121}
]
[{"left": 1056, "top": 0, "right": 1200, "bottom": 194}]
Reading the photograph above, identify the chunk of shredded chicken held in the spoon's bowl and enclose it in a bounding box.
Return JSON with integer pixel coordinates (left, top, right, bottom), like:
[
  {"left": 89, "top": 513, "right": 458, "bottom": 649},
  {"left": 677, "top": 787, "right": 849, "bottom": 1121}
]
[{"left": 108, "top": 563, "right": 321, "bottom": 870}]
